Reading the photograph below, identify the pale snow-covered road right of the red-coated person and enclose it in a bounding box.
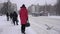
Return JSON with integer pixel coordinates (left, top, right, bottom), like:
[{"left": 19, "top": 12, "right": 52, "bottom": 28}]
[{"left": 29, "top": 15, "right": 60, "bottom": 34}]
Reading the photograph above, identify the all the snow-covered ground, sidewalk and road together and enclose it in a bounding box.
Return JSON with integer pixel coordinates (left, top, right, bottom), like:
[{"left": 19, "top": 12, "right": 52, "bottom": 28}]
[{"left": 0, "top": 15, "right": 60, "bottom": 34}]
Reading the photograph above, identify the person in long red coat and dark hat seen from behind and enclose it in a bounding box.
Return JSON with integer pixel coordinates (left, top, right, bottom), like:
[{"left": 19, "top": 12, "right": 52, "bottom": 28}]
[{"left": 20, "top": 4, "right": 28, "bottom": 34}]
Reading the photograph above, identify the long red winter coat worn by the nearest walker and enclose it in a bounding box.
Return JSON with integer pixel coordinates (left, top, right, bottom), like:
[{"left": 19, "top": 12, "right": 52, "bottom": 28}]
[{"left": 20, "top": 7, "right": 28, "bottom": 24}]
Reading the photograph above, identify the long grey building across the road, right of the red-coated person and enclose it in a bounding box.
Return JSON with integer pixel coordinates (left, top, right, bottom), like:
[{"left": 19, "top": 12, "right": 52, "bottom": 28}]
[{"left": 29, "top": 4, "right": 57, "bottom": 16}]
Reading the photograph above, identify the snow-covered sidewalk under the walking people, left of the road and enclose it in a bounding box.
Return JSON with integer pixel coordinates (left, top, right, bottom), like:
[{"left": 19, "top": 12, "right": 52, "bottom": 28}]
[{"left": 0, "top": 16, "right": 36, "bottom": 34}]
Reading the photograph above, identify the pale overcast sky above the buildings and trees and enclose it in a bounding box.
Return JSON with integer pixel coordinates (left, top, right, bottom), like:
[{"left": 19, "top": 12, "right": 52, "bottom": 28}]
[{"left": 0, "top": 0, "right": 57, "bottom": 10}]
